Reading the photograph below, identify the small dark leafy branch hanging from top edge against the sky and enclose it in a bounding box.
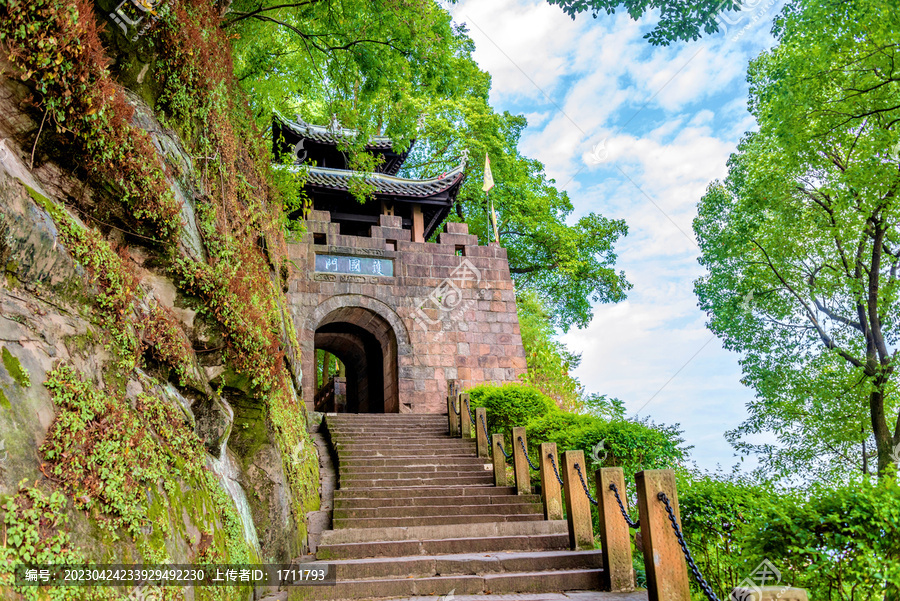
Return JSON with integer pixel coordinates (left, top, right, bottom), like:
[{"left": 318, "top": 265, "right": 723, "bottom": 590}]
[{"left": 547, "top": 0, "right": 743, "bottom": 46}]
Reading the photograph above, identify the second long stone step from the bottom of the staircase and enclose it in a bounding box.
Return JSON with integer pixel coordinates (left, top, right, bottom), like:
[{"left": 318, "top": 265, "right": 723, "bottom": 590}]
[{"left": 303, "top": 550, "right": 603, "bottom": 581}]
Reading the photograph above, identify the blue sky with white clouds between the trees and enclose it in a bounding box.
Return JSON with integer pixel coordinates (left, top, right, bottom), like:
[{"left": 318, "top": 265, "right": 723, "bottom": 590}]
[{"left": 450, "top": 0, "right": 783, "bottom": 470}]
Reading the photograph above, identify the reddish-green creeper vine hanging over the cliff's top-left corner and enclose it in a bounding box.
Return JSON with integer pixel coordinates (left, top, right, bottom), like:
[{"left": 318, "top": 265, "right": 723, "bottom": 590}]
[{"left": 0, "top": 0, "right": 182, "bottom": 240}]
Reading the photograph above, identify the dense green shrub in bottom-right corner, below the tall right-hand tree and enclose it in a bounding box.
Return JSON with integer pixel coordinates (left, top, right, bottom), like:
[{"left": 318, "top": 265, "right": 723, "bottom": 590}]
[{"left": 678, "top": 474, "right": 900, "bottom": 601}]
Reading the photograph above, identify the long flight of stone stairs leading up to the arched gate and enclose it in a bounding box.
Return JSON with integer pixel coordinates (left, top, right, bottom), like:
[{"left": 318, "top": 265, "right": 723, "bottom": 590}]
[{"left": 290, "top": 414, "right": 646, "bottom": 601}]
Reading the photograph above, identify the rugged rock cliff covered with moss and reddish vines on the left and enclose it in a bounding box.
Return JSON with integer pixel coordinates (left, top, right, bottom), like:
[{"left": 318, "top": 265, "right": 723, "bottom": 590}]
[{"left": 0, "top": 0, "right": 318, "bottom": 599}]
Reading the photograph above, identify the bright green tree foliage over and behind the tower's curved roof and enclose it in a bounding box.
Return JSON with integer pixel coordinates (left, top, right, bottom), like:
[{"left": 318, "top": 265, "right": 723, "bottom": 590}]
[{"left": 226, "top": 0, "right": 630, "bottom": 329}]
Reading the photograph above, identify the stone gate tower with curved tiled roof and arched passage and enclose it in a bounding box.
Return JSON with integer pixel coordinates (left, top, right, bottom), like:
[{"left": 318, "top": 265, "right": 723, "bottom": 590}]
[{"left": 273, "top": 117, "right": 525, "bottom": 413}]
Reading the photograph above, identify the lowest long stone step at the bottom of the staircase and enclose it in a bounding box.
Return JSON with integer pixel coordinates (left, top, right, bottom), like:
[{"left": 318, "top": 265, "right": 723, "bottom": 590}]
[{"left": 291, "top": 569, "right": 602, "bottom": 600}]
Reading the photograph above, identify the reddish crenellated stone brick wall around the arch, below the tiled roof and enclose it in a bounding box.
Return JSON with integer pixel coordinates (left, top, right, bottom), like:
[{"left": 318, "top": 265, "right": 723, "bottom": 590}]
[{"left": 288, "top": 211, "right": 525, "bottom": 413}]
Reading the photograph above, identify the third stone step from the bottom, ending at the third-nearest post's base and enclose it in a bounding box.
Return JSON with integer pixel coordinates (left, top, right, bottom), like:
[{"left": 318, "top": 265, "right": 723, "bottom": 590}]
[{"left": 321, "top": 520, "right": 569, "bottom": 550}]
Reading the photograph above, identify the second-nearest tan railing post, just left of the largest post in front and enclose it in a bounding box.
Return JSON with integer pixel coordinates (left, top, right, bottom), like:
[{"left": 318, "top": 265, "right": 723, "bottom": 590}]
[{"left": 596, "top": 467, "right": 634, "bottom": 592}]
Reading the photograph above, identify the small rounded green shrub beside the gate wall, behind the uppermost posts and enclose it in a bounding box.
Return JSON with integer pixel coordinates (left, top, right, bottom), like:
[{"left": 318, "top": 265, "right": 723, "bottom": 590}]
[{"left": 468, "top": 384, "right": 562, "bottom": 439}]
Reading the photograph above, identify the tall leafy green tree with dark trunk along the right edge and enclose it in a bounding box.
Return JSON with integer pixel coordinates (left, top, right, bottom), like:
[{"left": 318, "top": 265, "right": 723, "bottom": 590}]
[{"left": 694, "top": 0, "right": 900, "bottom": 475}]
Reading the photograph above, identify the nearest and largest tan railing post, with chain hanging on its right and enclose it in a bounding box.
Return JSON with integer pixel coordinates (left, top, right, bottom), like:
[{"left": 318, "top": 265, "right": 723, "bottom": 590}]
[{"left": 634, "top": 470, "right": 691, "bottom": 601}]
